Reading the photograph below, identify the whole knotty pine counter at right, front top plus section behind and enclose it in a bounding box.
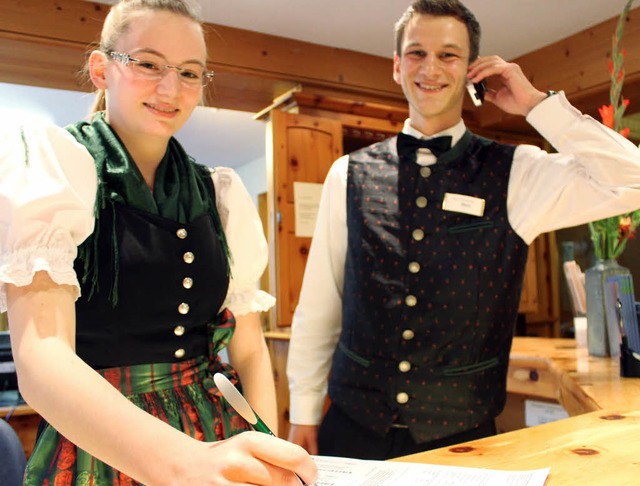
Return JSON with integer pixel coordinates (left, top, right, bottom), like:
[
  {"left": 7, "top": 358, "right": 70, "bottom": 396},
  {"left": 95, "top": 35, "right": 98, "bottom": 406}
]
[{"left": 394, "top": 338, "right": 640, "bottom": 486}]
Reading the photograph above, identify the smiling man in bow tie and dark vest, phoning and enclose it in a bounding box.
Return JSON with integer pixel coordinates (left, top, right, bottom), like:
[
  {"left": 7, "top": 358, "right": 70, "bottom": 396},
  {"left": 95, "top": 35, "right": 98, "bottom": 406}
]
[{"left": 288, "top": 0, "right": 640, "bottom": 459}]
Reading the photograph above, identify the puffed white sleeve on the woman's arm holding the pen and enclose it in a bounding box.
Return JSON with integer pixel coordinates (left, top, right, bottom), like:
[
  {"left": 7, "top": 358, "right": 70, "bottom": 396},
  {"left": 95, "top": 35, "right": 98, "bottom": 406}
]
[{"left": 0, "top": 122, "right": 97, "bottom": 312}]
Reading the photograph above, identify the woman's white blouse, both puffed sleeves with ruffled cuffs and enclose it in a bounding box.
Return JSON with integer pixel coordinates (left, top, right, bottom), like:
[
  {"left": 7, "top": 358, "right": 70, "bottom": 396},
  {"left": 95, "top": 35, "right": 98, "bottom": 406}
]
[{"left": 0, "top": 122, "right": 275, "bottom": 315}]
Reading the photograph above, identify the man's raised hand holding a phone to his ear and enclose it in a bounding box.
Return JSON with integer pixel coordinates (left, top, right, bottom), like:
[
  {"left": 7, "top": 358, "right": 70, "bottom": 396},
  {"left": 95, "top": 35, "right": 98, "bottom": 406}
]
[{"left": 467, "top": 56, "right": 547, "bottom": 116}]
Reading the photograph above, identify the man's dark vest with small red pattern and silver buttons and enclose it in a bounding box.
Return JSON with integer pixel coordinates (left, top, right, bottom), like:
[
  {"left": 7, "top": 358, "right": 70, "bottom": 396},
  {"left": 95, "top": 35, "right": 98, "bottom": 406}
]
[{"left": 329, "top": 132, "right": 528, "bottom": 443}]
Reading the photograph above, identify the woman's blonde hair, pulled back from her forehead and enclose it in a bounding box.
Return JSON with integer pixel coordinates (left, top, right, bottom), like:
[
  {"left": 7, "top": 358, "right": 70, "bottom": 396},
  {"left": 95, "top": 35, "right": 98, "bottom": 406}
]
[{"left": 91, "top": 0, "right": 202, "bottom": 116}]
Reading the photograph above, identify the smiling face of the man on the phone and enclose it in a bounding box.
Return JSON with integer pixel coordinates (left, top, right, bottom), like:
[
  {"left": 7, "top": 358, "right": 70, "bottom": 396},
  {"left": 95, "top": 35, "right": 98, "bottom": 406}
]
[{"left": 393, "top": 15, "right": 469, "bottom": 135}]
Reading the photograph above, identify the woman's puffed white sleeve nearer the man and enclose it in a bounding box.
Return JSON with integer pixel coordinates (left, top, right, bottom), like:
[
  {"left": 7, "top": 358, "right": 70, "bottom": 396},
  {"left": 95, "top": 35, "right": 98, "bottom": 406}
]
[{"left": 211, "top": 167, "right": 276, "bottom": 315}]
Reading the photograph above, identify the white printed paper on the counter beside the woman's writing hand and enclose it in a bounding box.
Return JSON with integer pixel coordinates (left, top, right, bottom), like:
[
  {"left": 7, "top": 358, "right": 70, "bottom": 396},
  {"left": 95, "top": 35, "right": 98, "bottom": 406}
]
[{"left": 313, "top": 456, "right": 550, "bottom": 486}]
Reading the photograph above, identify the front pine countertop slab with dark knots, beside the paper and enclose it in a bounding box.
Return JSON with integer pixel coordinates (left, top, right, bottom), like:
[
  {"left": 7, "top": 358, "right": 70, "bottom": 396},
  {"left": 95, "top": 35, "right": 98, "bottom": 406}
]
[{"left": 394, "top": 410, "right": 640, "bottom": 486}]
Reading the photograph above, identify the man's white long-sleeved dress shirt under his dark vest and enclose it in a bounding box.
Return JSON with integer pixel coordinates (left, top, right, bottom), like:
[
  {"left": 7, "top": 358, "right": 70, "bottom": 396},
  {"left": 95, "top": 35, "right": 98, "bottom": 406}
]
[{"left": 287, "top": 93, "right": 640, "bottom": 425}]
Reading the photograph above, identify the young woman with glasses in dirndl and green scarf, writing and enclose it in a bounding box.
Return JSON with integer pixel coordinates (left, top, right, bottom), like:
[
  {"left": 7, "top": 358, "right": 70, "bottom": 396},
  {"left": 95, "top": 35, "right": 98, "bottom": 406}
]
[{"left": 0, "top": 0, "right": 316, "bottom": 485}]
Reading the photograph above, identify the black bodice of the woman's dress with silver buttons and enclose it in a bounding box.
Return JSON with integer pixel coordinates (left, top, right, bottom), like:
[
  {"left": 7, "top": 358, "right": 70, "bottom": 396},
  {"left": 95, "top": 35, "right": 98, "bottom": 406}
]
[{"left": 75, "top": 197, "right": 229, "bottom": 369}]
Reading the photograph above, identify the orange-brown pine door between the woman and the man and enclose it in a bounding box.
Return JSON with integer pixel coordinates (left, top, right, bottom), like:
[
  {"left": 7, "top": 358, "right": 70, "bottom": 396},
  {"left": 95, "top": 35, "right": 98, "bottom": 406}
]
[{"left": 267, "top": 110, "right": 342, "bottom": 330}]
